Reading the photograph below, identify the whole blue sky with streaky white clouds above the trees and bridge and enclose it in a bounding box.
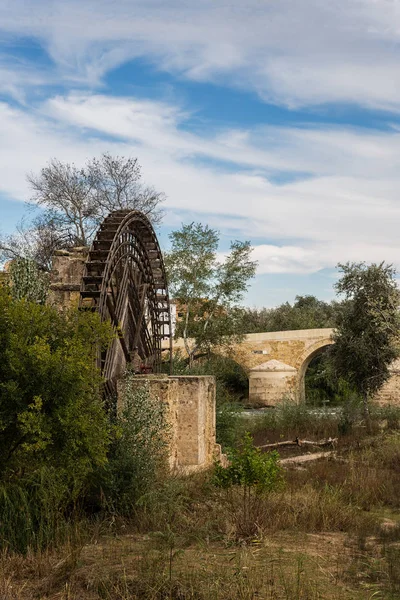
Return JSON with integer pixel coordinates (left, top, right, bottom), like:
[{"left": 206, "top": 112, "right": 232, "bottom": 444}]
[{"left": 0, "top": 0, "right": 400, "bottom": 306}]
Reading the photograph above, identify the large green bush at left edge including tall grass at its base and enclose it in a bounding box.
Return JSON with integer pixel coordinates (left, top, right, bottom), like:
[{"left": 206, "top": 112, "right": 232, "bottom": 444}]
[{"left": 0, "top": 288, "right": 112, "bottom": 552}]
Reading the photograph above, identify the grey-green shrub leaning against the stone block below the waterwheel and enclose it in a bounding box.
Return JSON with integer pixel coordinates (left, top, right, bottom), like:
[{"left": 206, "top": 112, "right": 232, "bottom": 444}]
[{"left": 93, "top": 372, "right": 169, "bottom": 515}]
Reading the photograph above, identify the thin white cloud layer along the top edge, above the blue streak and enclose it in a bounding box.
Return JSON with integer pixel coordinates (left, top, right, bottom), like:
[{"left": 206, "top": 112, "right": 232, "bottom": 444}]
[{"left": 0, "top": 0, "right": 400, "bottom": 111}]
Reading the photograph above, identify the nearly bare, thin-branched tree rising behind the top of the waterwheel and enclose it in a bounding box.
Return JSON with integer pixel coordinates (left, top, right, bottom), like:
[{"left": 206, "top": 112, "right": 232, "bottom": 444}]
[{"left": 0, "top": 153, "right": 164, "bottom": 270}]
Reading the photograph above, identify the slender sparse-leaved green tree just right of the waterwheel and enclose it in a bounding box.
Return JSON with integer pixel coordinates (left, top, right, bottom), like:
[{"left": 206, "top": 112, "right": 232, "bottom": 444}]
[{"left": 165, "top": 223, "right": 256, "bottom": 366}]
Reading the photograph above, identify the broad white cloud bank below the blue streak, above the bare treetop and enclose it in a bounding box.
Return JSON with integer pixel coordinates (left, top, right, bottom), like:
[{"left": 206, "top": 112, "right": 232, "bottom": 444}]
[{"left": 0, "top": 95, "right": 400, "bottom": 273}]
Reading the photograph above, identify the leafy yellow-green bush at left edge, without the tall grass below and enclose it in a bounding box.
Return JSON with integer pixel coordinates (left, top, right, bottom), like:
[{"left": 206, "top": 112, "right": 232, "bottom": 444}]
[{"left": 0, "top": 289, "right": 111, "bottom": 488}]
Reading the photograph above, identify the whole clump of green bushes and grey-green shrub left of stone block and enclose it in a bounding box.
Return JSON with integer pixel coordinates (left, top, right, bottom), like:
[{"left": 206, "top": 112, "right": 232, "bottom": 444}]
[{"left": 0, "top": 287, "right": 172, "bottom": 553}]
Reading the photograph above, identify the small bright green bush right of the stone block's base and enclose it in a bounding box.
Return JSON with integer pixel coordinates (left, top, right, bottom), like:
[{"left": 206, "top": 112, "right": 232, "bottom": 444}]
[{"left": 214, "top": 433, "right": 282, "bottom": 492}]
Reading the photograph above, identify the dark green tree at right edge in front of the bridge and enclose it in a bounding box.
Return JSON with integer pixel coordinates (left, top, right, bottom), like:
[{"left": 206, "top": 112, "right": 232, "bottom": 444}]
[{"left": 330, "top": 263, "right": 400, "bottom": 423}]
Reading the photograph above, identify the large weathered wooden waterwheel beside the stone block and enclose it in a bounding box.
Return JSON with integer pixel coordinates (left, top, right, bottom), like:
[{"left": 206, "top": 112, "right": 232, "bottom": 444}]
[{"left": 80, "top": 210, "right": 172, "bottom": 394}]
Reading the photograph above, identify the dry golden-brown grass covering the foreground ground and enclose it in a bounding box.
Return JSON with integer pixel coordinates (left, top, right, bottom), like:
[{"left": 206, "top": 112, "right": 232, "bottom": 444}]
[{"left": 0, "top": 406, "right": 400, "bottom": 600}]
